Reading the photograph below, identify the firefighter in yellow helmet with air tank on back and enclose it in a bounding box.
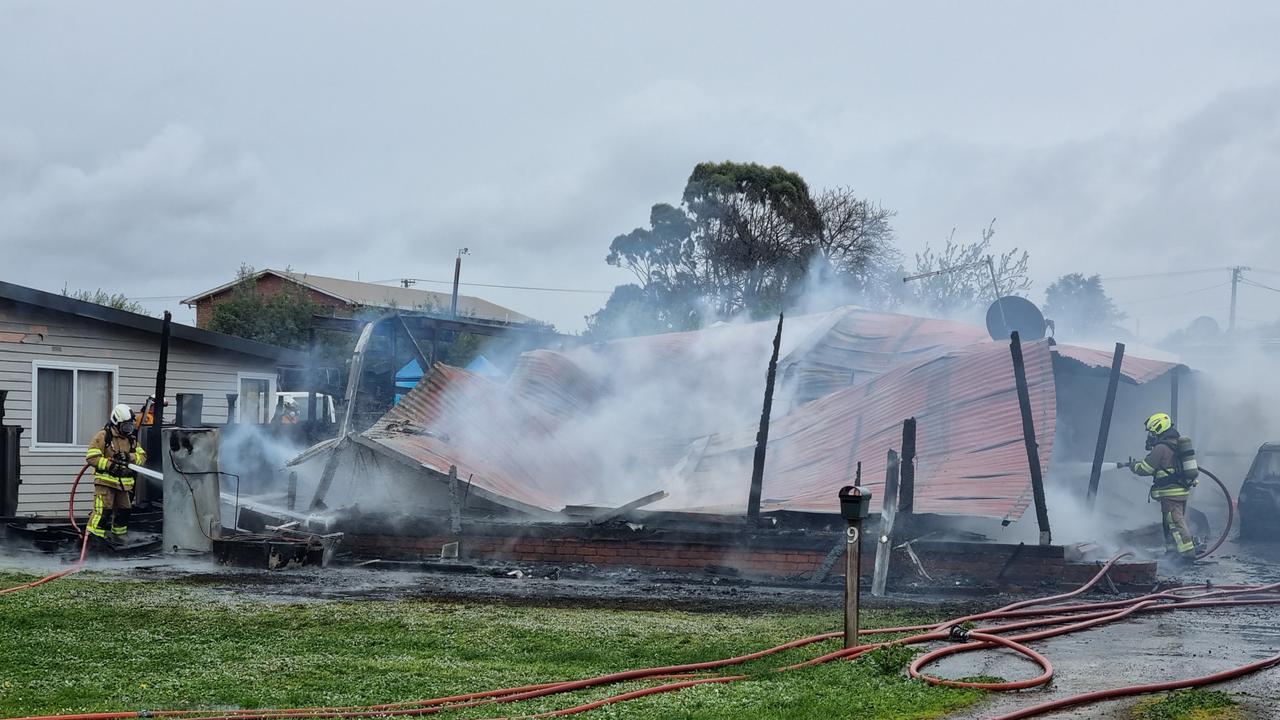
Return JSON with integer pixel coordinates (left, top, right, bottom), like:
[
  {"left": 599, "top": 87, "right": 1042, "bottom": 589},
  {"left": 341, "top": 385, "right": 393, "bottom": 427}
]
[{"left": 1130, "top": 413, "right": 1196, "bottom": 562}]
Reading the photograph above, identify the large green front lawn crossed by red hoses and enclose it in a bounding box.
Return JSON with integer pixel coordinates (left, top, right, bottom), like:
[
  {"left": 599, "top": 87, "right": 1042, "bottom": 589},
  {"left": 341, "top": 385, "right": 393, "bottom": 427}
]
[{"left": 0, "top": 573, "right": 982, "bottom": 720}]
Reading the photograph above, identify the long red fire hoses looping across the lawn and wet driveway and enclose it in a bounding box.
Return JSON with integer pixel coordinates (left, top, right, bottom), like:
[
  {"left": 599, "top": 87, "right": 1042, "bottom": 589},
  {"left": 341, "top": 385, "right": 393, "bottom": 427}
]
[{"left": 10, "top": 553, "right": 1280, "bottom": 720}]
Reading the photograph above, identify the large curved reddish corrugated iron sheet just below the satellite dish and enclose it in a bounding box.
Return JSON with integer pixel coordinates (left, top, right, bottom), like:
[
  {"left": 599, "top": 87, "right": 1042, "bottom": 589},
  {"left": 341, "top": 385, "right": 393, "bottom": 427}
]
[{"left": 654, "top": 341, "right": 1056, "bottom": 519}]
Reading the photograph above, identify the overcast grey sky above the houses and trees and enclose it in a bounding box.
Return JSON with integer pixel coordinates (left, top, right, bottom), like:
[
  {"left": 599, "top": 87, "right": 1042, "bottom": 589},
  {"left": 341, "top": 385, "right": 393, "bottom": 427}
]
[{"left": 0, "top": 0, "right": 1280, "bottom": 336}]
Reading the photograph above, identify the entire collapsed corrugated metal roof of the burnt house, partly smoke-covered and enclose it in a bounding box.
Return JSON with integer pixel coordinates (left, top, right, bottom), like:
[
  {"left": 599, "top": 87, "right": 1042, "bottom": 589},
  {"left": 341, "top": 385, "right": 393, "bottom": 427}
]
[{"left": 365, "top": 307, "right": 1174, "bottom": 519}]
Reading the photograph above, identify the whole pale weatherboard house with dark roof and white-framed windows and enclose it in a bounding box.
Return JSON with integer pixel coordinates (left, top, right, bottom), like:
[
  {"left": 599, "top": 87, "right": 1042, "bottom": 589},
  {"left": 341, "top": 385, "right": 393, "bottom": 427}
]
[{"left": 0, "top": 282, "right": 306, "bottom": 516}]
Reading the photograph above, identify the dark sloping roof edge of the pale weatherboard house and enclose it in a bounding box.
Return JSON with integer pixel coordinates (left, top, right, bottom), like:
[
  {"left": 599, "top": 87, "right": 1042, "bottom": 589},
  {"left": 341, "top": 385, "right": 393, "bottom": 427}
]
[{"left": 0, "top": 282, "right": 306, "bottom": 365}]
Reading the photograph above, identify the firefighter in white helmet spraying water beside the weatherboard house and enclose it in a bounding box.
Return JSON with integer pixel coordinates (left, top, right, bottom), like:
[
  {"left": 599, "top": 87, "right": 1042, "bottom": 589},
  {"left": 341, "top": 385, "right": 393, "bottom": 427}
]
[{"left": 84, "top": 405, "right": 147, "bottom": 544}]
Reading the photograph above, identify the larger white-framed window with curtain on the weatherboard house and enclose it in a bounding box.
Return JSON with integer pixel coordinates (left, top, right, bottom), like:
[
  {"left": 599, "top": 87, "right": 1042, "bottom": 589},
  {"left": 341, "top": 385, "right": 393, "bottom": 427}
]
[{"left": 32, "top": 363, "right": 116, "bottom": 448}]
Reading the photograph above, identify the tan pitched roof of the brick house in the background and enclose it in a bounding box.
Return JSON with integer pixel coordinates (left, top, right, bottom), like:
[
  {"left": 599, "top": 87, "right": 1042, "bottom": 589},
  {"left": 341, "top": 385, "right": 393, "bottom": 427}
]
[{"left": 182, "top": 269, "right": 532, "bottom": 323}]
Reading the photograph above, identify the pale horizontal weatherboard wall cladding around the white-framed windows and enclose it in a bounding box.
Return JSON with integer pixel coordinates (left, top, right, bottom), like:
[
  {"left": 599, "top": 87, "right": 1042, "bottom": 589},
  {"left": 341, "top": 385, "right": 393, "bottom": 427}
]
[{"left": 0, "top": 302, "right": 276, "bottom": 516}]
